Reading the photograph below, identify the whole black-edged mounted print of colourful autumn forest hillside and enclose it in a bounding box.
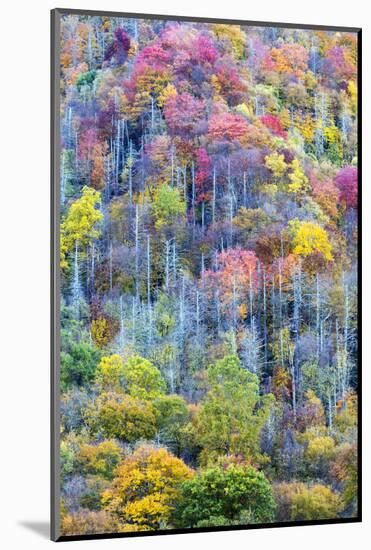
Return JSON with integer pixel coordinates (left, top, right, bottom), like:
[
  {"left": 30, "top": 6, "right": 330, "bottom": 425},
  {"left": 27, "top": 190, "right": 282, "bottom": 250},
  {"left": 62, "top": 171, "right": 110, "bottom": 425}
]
[{"left": 51, "top": 9, "right": 361, "bottom": 541}]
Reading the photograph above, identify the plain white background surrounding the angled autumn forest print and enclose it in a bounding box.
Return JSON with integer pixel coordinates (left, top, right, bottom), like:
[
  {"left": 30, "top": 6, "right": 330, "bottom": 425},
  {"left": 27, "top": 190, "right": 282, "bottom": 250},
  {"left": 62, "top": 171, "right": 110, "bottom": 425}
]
[{"left": 0, "top": 0, "right": 371, "bottom": 550}]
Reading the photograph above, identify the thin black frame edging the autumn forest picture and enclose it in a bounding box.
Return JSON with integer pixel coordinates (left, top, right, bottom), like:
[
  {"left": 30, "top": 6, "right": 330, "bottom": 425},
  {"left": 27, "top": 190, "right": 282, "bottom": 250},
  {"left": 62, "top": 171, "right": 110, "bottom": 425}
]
[{"left": 50, "top": 8, "right": 362, "bottom": 542}]
